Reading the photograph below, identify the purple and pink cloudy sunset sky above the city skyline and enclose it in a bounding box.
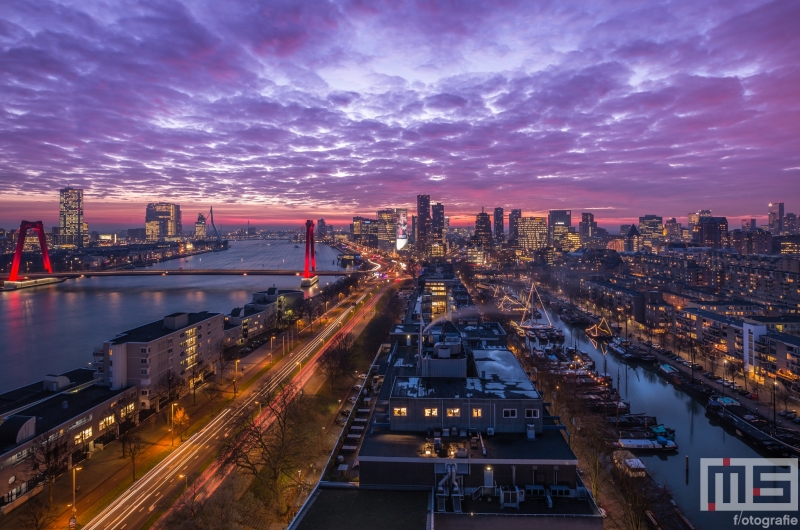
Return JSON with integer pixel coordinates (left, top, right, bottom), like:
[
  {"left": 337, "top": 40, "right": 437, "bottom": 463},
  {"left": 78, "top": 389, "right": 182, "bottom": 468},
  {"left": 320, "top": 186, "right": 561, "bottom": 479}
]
[{"left": 0, "top": 0, "right": 800, "bottom": 229}]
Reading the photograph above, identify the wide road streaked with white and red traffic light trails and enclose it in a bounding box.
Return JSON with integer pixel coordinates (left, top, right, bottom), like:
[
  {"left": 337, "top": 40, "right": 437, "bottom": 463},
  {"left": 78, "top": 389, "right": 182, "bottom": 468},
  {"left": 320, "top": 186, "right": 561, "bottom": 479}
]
[{"left": 83, "top": 285, "right": 388, "bottom": 530}]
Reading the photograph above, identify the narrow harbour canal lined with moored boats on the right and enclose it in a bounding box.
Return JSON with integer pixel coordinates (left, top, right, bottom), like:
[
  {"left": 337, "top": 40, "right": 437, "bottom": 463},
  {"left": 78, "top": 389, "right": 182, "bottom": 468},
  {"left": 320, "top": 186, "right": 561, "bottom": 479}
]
[{"left": 528, "top": 304, "right": 764, "bottom": 529}]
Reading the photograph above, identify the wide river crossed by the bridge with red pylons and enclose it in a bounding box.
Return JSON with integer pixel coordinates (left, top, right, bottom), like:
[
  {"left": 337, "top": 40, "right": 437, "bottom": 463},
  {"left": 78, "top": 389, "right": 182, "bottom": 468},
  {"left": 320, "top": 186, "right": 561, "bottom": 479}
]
[{"left": 0, "top": 240, "right": 339, "bottom": 392}]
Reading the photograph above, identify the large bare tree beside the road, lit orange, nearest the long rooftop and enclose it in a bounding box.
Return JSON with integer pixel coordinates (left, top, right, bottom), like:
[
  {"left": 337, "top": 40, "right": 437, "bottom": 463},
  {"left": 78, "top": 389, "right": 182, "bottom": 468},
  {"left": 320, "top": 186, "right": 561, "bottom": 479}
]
[{"left": 222, "top": 383, "right": 321, "bottom": 515}]
